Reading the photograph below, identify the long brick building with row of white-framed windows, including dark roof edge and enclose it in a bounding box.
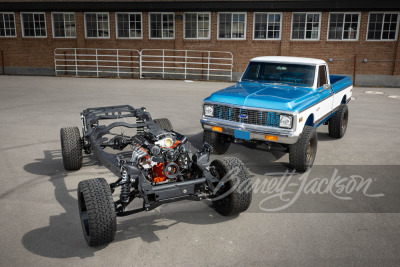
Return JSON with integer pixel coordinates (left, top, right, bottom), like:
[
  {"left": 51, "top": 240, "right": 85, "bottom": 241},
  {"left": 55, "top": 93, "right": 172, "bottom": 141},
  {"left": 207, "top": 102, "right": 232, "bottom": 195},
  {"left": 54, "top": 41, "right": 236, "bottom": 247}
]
[{"left": 0, "top": 0, "right": 400, "bottom": 86}]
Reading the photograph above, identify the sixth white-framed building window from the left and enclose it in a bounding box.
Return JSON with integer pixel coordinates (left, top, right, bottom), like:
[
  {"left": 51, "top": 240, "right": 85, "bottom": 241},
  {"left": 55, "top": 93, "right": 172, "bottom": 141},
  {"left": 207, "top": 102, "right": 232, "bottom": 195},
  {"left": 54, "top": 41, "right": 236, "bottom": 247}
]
[{"left": 149, "top": 13, "right": 175, "bottom": 39}]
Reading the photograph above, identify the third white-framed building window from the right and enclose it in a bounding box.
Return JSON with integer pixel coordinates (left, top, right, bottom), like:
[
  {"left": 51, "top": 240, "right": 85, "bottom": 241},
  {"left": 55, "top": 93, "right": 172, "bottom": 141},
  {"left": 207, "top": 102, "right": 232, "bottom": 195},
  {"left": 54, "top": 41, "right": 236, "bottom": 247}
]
[{"left": 292, "top": 13, "right": 321, "bottom": 40}]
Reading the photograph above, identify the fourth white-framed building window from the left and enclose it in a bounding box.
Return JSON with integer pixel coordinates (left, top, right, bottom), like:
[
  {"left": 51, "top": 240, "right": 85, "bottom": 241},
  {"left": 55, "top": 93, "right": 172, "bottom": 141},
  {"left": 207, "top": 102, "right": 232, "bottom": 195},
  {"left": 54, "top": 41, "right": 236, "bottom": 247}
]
[{"left": 85, "top": 13, "right": 110, "bottom": 38}]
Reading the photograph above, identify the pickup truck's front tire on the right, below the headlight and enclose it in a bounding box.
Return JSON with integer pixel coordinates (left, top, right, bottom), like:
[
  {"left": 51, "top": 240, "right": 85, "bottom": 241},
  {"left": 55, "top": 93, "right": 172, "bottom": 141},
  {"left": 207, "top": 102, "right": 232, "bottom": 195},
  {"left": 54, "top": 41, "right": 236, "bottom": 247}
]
[{"left": 289, "top": 126, "right": 318, "bottom": 172}]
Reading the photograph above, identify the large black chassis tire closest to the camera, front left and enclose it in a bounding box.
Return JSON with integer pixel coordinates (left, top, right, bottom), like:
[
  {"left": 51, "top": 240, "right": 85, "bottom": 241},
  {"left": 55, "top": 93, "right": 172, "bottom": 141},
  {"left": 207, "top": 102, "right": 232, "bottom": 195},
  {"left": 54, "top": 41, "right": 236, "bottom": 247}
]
[{"left": 78, "top": 178, "right": 117, "bottom": 247}]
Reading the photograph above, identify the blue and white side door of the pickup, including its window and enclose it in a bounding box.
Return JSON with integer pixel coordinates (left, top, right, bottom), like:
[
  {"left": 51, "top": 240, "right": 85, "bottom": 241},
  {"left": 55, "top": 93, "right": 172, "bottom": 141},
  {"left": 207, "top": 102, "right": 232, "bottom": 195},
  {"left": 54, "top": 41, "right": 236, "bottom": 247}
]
[{"left": 316, "top": 65, "right": 334, "bottom": 123}]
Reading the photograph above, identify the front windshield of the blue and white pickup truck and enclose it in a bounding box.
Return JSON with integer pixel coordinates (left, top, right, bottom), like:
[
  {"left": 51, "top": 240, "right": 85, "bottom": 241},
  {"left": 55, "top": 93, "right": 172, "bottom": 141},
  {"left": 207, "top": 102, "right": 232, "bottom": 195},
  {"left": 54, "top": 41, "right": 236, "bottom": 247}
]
[{"left": 242, "top": 62, "right": 315, "bottom": 87}]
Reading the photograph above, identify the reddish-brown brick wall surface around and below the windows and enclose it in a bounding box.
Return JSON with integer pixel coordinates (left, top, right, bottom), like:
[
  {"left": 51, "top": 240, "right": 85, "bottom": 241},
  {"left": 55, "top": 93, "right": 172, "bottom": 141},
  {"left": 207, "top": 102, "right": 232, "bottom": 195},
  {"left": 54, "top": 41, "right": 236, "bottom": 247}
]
[{"left": 0, "top": 12, "right": 400, "bottom": 78}]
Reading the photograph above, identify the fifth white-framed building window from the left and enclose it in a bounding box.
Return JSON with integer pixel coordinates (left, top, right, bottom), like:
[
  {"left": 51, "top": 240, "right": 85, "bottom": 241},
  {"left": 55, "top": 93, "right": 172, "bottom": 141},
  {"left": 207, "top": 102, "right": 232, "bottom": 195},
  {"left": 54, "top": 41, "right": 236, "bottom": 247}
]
[{"left": 116, "top": 13, "right": 142, "bottom": 38}]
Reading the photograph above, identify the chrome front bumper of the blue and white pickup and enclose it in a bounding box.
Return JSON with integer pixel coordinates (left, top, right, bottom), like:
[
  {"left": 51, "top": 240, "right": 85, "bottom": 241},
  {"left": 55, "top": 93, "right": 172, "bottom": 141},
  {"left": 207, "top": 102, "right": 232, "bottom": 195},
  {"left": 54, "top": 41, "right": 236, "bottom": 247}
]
[{"left": 200, "top": 117, "right": 299, "bottom": 144}]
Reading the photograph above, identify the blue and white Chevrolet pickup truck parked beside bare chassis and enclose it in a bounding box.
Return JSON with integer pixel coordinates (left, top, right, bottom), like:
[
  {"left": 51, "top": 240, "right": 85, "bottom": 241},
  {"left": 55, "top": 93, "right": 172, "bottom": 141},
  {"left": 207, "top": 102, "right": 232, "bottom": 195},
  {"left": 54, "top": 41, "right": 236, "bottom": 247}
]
[{"left": 201, "top": 56, "right": 353, "bottom": 172}]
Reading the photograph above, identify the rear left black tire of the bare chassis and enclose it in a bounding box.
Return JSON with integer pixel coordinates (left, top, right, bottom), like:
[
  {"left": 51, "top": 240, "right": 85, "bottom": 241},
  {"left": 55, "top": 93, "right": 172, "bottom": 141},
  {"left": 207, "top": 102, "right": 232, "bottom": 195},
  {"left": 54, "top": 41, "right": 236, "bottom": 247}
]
[{"left": 60, "top": 127, "right": 82, "bottom": 171}]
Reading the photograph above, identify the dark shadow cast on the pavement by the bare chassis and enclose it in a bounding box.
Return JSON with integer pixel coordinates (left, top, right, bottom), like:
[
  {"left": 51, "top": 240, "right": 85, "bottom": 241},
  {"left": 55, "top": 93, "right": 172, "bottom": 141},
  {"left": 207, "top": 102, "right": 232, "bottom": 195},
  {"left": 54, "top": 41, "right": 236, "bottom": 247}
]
[{"left": 22, "top": 150, "right": 235, "bottom": 258}]
